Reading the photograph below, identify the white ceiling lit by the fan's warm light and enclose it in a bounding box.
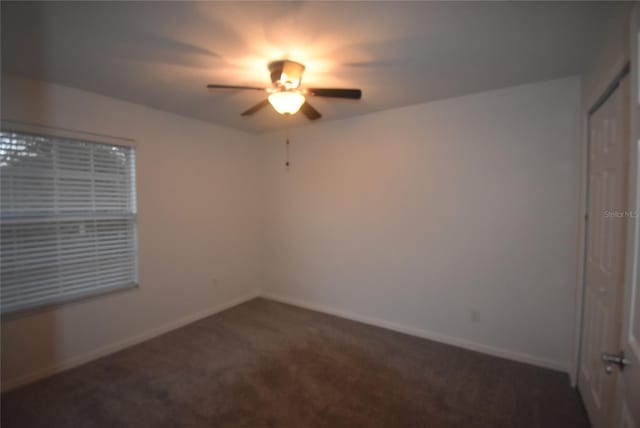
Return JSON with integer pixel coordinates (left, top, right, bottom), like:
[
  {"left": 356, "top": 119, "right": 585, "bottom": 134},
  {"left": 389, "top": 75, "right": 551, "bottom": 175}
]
[{"left": 2, "top": 1, "right": 625, "bottom": 132}]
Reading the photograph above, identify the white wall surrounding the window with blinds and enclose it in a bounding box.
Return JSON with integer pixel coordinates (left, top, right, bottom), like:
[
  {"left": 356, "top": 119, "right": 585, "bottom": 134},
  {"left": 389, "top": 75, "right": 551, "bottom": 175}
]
[{"left": 2, "top": 75, "right": 260, "bottom": 388}]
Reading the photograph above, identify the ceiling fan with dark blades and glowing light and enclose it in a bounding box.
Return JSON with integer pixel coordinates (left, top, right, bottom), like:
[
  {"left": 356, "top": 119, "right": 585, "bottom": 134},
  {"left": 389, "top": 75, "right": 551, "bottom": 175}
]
[{"left": 207, "top": 59, "right": 362, "bottom": 120}]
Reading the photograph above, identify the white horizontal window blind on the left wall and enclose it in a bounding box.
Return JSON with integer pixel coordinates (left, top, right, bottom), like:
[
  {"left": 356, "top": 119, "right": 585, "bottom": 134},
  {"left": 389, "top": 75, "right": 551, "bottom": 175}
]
[{"left": 0, "top": 131, "right": 138, "bottom": 313}]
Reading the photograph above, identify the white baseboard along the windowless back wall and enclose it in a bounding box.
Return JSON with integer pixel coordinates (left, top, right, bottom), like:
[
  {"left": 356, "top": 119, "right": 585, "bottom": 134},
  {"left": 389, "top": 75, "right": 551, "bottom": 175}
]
[{"left": 260, "top": 292, "right": 569, "bottom": 372}]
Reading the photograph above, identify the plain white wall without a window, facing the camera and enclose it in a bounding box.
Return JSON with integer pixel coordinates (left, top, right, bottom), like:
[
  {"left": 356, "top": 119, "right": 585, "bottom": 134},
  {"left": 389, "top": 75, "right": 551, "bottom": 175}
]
[{"left": 264, "top": 77, "right": 580, "bottom": 369}]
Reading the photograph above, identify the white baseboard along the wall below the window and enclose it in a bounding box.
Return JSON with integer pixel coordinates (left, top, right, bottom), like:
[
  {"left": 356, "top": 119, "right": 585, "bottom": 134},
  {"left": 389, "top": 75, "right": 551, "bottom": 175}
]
[{"left": 2, "top": 292, "right": 260, "bottom": 392}]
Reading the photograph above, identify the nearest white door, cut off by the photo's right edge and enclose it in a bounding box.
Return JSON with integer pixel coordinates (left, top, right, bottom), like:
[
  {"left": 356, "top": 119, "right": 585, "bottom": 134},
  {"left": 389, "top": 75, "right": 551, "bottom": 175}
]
[{"left": 614, "top": 5, "right": 640, "bottom": 428}]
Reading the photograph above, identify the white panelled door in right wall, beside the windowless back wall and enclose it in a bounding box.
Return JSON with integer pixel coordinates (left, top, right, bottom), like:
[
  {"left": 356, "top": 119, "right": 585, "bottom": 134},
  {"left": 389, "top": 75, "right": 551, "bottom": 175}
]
[{"left": 578, "top": 72, "right": 629, "bottom": 428}]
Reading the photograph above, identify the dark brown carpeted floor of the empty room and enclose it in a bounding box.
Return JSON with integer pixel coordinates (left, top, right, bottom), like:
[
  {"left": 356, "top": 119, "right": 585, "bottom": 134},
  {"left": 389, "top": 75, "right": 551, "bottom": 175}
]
[{"left": 2, "top": 299, "right": 588, "bottom": 428}]
